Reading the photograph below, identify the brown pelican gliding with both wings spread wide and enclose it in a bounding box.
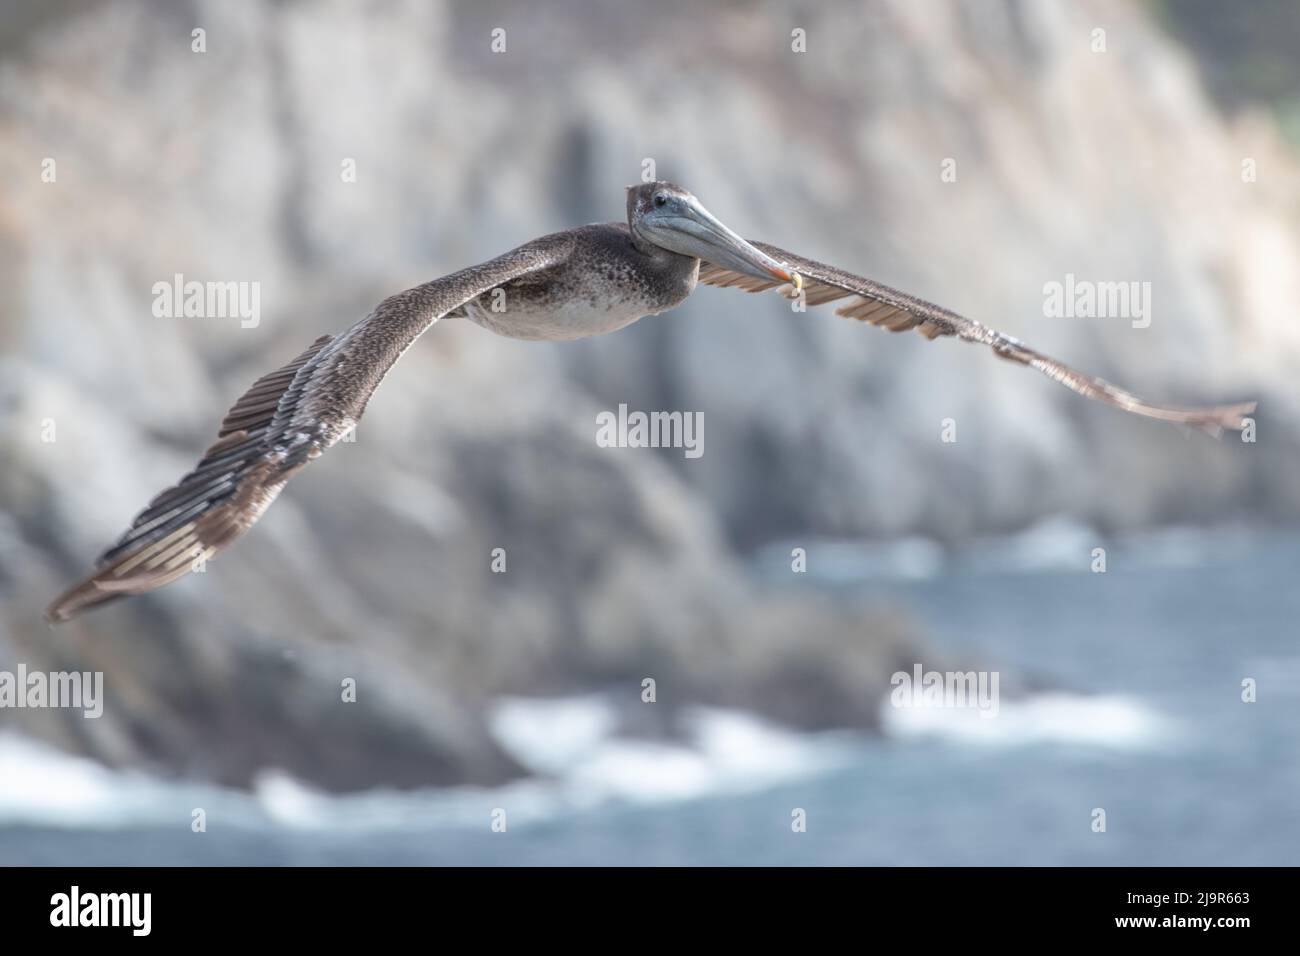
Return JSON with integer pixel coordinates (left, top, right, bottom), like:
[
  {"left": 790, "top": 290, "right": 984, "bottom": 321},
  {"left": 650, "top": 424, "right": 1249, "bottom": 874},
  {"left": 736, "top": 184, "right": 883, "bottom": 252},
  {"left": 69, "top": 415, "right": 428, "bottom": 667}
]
[{"left": 46, "top": 182, "right": 1255, "bottom": 622}]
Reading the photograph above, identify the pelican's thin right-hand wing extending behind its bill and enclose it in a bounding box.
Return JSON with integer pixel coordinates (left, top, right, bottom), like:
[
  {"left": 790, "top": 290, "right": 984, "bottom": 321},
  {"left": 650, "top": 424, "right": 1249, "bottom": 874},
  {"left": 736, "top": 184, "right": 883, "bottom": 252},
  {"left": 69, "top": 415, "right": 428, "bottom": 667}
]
[{"left": 699, "top": 242, "right": 1255, "bottom": 436}]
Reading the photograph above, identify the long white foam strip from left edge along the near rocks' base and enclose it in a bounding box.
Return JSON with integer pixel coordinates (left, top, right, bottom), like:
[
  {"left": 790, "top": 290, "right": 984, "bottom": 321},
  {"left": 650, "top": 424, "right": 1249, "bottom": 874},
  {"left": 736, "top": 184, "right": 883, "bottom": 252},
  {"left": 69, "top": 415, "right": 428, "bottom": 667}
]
[{"left": 0, "top": 696, "right": 849, "bottom": 831}]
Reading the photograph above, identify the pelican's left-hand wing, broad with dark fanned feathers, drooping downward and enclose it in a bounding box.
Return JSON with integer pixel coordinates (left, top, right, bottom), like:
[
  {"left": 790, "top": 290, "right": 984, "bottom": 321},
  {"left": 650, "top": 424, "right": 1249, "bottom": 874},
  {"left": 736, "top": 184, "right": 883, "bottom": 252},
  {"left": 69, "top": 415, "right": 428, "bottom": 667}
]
[{"left": 46, "top": 233, "right": 571, "bottom": 622}]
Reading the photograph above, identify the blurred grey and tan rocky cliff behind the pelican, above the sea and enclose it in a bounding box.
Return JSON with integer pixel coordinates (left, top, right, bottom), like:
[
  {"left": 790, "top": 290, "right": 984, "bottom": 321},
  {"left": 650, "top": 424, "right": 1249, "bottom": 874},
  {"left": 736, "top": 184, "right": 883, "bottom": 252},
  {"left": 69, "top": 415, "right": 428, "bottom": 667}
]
[{"left": 0, "top": 0, "right": 1300, "bottom": 787}]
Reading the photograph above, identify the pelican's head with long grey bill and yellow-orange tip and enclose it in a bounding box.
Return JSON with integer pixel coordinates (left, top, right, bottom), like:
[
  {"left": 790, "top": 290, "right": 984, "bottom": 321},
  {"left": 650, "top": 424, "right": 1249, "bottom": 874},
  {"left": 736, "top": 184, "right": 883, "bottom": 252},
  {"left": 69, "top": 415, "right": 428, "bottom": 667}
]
[{"left": 628, "top": 182, "right": 803, "bottom": 289}]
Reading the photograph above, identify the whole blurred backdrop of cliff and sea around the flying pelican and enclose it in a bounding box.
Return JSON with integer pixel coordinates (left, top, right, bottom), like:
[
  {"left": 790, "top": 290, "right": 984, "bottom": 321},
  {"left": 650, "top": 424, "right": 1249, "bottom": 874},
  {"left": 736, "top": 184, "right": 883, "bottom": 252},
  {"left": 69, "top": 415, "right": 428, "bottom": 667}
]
[{"left": 0, "top": 0, "right": 1300, "bottom": 865}]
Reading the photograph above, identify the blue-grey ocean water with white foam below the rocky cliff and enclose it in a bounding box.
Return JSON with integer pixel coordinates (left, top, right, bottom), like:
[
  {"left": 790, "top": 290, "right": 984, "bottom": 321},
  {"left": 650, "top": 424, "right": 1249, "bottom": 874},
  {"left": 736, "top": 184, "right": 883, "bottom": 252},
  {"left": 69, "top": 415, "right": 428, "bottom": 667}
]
[{"left": 0, "top": 523, "right": 1300, "bottom": 865}]
